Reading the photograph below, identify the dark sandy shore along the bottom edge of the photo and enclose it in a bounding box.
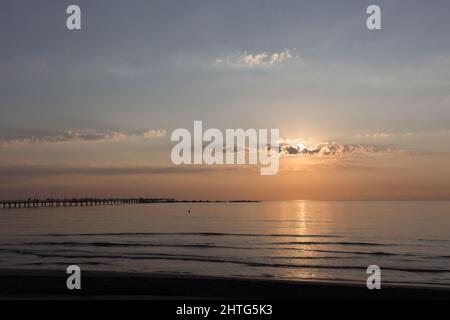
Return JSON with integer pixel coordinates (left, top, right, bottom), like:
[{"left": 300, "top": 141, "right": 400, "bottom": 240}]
[{"left": 0, "top": 270, "right": 450, "bottom": 300}]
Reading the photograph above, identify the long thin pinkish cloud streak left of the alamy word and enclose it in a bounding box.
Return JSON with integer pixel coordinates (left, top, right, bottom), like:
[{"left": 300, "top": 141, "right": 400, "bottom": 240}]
[{"left": 0, "top": 129, "right": 166, "bottom": 147}]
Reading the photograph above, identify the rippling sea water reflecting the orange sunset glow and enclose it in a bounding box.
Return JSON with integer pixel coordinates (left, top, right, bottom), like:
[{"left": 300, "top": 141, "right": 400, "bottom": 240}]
[{"left": 0, "top": 201, "right": 450, "bottom": 287}]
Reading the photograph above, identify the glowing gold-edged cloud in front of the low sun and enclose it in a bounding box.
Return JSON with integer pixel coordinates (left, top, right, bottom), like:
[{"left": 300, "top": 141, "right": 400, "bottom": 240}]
[{"left": 279, "top": 139, "right": 407, "bottom": 157}]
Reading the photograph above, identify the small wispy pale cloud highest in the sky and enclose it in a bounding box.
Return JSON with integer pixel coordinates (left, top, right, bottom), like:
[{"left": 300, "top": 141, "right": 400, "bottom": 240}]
[{"left": 215, "top": 48, "right": 297, "bottom": 68}]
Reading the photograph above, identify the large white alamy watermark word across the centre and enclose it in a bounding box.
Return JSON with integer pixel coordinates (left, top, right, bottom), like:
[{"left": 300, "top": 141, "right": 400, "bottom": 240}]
[{"left": 170, "top": 121, "right": 280, "bottom": 175}]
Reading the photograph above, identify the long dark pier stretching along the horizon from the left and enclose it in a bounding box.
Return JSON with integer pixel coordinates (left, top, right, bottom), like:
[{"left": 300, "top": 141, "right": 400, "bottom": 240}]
[{"left": 0, "top": 198, "right": 259, "bottom": 209}]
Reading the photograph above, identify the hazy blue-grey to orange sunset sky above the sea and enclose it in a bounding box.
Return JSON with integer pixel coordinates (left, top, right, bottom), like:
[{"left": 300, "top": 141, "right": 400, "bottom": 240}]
[{"left": 0, "top": 0, "right": 450, "bottom": 200}]
